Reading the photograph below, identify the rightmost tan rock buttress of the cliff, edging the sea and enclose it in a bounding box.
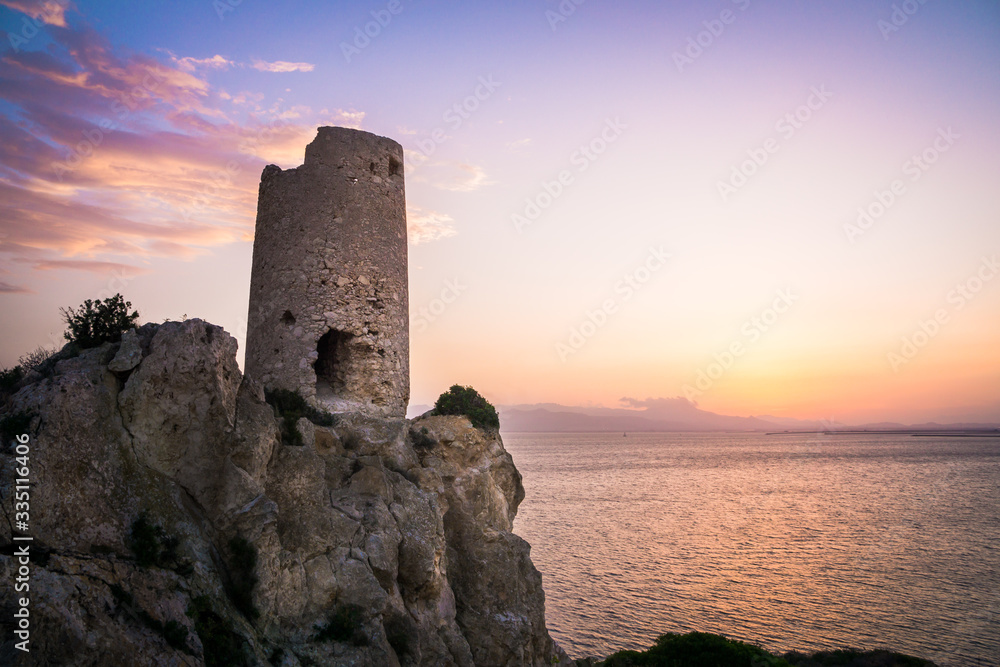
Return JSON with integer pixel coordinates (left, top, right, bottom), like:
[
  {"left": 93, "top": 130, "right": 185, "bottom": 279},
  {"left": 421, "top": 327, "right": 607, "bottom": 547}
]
[{"left": 414, "top": 416, "right": 565, "bottom": 665}]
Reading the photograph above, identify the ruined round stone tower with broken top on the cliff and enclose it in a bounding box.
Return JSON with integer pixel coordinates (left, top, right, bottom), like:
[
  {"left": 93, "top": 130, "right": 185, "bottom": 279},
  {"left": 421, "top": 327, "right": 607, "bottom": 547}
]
[{"left": 246, "top": 127, "right": 410, "bottom": 417}]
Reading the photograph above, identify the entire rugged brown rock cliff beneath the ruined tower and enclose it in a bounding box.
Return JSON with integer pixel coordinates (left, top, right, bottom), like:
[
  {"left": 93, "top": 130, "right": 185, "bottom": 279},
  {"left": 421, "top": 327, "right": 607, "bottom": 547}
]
[{"left": 0, "top": 320, "right": 571, "bottom": 667}]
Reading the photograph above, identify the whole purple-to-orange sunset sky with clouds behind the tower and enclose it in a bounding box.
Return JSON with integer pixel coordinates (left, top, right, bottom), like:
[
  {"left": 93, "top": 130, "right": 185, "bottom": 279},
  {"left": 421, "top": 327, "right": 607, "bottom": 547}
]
[{"left": 0, "top": 0, "right": 1000, "bottom": 423}]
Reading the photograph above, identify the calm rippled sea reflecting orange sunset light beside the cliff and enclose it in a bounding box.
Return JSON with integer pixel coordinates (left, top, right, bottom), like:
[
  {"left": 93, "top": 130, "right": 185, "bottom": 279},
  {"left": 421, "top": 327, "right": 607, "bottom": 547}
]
[{"left": 504, "top": 433, "right": 1000, "bottom": 666}]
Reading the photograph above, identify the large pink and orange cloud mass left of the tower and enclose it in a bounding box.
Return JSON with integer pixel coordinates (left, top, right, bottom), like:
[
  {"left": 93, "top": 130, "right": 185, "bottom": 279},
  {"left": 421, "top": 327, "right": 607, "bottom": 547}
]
[{"left": 0, "top": 19, "right": 364, "bottom": 293}]
